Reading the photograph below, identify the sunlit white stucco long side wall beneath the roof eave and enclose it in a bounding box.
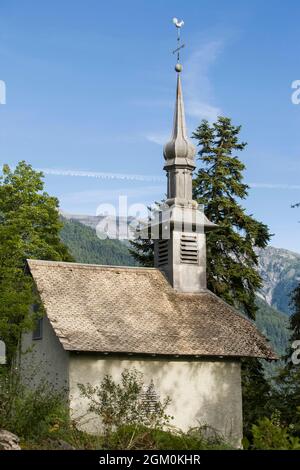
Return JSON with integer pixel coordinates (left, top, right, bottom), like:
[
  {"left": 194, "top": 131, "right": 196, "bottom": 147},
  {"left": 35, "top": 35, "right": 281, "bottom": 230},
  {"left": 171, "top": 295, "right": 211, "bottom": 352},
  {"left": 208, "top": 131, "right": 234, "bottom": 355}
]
[{"left": 69, "top": 354, "right": 242, "bottom": 447}]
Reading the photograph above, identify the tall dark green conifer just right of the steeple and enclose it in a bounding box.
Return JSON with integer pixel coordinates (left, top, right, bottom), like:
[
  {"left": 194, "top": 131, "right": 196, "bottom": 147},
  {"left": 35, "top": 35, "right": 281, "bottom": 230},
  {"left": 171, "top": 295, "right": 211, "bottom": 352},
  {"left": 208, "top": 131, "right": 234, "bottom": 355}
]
[{"left": 193, "top": 117, "right": 270, "bottom": 318}]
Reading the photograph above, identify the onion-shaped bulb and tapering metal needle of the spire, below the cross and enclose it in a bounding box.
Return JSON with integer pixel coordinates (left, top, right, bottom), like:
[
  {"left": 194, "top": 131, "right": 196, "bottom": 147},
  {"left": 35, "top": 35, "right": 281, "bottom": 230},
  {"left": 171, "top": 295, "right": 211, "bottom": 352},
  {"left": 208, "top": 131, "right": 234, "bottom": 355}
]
[{"left": 164, "top": 72, "right": 196, "bottom": 169}]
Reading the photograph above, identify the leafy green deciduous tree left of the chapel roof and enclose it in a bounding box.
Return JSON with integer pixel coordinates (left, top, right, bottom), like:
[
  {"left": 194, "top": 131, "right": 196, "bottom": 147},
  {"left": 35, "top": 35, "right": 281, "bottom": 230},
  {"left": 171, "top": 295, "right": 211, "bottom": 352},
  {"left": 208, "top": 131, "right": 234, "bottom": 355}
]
[{"left": 0, "top": 161, "right": 72, "bottom": 361}]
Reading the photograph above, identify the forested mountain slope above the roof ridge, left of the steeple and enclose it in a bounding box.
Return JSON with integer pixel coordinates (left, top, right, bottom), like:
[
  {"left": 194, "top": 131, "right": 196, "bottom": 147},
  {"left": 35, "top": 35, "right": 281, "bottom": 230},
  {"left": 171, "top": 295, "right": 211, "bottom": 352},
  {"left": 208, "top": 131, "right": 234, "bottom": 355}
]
[{"left": 60, "top": 217, "right": 136, "bottom": 266}]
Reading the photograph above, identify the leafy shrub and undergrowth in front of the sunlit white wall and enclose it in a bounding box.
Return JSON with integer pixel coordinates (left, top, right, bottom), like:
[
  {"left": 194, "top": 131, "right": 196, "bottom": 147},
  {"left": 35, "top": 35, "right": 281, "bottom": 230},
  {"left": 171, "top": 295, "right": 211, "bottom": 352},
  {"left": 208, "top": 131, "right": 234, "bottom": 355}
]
[{"left": 78, "top": 369, "right": 228, "bottom": 450}]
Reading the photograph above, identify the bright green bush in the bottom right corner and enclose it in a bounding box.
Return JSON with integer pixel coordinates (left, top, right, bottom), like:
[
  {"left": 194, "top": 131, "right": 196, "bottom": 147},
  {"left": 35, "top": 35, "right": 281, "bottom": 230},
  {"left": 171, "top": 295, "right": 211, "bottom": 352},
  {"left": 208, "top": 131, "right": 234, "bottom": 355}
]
[{"left": 252, "top": 413, "right": 300, "bottom": 450}]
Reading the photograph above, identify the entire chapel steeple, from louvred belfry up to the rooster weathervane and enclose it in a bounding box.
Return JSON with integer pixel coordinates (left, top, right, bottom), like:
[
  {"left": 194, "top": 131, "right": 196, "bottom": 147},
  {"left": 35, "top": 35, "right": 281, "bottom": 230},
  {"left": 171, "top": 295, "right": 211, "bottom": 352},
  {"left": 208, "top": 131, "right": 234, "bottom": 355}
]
[{"left": 151, "top": 18, "right": 216, "bottom": 293}]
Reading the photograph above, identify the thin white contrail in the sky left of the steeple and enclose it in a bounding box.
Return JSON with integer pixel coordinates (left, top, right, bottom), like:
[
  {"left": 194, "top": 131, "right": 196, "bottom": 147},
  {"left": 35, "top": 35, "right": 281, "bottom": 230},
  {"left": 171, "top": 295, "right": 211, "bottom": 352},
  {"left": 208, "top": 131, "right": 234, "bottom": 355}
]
[{"left": 36, "top": 168, "right": 165, "bottom": 183}]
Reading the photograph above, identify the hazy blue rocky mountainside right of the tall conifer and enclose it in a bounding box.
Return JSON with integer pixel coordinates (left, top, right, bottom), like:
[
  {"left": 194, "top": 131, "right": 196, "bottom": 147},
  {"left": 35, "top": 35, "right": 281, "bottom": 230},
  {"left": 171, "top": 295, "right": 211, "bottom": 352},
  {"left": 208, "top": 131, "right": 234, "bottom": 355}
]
[{"left": 257, "top": 246, "right": 300, "bottom": 315}]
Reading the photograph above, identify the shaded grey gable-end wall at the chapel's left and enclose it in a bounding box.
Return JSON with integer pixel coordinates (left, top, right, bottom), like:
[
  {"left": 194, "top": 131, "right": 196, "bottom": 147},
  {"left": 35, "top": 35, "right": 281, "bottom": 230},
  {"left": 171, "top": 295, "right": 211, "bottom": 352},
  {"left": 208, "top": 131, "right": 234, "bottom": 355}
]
[{"left": 20, "top": 317, "right": 69, "bottom": 393}]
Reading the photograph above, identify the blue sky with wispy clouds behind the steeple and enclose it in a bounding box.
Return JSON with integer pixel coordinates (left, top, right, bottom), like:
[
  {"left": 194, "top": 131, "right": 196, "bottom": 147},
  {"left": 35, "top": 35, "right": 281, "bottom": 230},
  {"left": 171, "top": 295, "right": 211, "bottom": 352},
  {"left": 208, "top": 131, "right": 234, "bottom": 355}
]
[{"left": 0, "top": 0, "right": 300, "bottom": 252}]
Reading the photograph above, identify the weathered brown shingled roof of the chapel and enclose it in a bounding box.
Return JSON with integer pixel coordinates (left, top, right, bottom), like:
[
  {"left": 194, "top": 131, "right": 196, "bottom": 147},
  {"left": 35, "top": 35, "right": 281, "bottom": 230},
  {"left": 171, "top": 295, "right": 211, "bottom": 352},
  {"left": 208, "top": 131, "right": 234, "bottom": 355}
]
[{"left": 28, "top": 260, "right": 276, "bottom": 359}]
